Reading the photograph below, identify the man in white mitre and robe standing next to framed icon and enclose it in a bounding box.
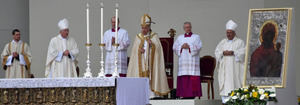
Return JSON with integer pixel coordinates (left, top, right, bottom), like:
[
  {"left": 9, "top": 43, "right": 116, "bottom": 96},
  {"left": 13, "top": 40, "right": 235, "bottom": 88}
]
[{"left": 215, "top": 20, "right": 245, "bottom": 103}]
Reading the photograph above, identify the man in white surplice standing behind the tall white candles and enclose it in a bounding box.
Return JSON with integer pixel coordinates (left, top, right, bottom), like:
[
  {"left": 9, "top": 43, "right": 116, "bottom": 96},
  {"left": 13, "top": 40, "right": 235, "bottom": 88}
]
[{"left": 104, "top": 17, "right": 130, "bottom": 77}]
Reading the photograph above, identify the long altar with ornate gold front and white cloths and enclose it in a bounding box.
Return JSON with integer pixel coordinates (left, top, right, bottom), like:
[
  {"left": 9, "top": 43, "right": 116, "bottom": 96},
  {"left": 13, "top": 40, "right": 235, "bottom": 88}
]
[{"left": 0, "top": 78, "right": 149, "bottom": 105}]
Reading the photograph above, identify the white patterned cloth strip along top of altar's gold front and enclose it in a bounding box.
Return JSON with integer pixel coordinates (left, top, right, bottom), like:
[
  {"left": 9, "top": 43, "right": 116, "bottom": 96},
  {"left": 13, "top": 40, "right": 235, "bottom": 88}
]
[{"left": 0, "top": 78, "right": 115, "bottom": 88}]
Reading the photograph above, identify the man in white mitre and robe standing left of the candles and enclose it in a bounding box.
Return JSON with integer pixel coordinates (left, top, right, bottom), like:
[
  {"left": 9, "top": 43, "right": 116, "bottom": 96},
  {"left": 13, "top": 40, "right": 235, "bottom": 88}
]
[{"left": 45, "top": 19, "right": 79, "bottom": 78}]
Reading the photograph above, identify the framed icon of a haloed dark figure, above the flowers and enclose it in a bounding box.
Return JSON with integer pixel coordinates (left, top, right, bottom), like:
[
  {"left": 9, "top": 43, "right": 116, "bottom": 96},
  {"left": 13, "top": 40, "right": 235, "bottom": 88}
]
[{"left": 244, "top": 8, "right": 292, "bottom": 88}]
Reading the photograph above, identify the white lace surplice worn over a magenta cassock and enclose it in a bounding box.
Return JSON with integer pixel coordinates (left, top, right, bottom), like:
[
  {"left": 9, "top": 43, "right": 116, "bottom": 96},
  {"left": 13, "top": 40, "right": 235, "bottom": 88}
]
[{"left": 173, "top": 34, "right": 202, "bottom": 76}]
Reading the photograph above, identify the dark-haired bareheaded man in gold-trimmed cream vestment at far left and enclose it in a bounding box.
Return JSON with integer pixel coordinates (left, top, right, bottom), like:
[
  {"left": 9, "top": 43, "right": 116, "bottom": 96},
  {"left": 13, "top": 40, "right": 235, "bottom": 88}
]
[{"left": 1, "top": 29, "right": 31, "bottom": 78}]
